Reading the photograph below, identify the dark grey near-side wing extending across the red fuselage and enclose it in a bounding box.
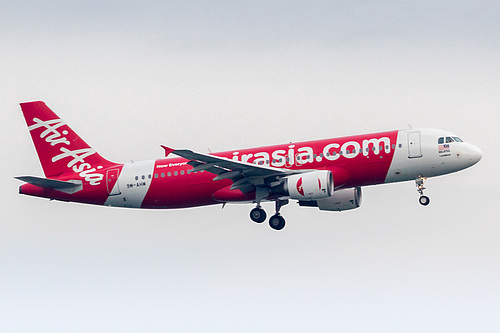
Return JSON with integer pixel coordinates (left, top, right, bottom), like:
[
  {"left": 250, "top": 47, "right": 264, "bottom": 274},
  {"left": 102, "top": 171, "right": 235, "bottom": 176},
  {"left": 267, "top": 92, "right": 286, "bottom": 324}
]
[{"left": 167, "top": 147, "right": 304, "bottom": 193}]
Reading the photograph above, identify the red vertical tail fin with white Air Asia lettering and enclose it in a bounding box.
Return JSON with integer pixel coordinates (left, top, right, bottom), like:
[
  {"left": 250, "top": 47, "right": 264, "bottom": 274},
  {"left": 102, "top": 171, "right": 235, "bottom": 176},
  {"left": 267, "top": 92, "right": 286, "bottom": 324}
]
[{"left": 21, "top": 101, "right": 116, "bottom": 185}]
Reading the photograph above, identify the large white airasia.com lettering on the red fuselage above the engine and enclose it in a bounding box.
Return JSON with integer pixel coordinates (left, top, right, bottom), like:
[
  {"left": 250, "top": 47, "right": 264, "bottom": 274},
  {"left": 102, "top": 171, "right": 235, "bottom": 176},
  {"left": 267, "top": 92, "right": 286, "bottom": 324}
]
[{"left": 232, "top": 137, "right": 391, "bottom": 168}]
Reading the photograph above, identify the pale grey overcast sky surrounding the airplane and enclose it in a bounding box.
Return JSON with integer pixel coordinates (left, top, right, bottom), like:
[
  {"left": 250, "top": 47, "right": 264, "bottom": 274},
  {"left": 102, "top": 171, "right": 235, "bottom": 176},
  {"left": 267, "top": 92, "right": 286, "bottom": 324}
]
[{"left": 0, "top": 0, "right": 500, "bottom": 332}]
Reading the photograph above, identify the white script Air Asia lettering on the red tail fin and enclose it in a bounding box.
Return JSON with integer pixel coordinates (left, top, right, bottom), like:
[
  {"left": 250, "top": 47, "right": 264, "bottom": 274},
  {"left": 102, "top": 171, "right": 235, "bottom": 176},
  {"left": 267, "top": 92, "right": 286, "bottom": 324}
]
[{"left": 28, "top": 118, "right": 104, "bottom": 185}]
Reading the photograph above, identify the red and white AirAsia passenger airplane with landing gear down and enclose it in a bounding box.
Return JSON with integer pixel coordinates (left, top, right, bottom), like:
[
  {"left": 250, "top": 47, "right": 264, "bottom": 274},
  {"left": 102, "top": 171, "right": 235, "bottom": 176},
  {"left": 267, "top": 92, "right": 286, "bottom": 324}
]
[{"left": 15, "top": 101, "right": 482, "bottom": 230}]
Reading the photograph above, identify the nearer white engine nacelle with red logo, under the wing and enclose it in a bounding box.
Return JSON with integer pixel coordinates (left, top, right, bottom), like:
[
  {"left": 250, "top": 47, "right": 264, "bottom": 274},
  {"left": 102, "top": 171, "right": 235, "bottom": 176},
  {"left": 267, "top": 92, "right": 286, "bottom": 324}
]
[{"left": 284, "top": 170, "right": 334, "bottom": 200}]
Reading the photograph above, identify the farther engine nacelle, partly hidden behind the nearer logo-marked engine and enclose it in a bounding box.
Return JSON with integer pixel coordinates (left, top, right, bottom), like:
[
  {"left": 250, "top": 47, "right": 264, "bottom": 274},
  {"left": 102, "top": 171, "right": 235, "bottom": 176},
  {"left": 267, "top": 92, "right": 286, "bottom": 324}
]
[{"left": 299, "top": 187, "right": 362, "bottom": 212}]
